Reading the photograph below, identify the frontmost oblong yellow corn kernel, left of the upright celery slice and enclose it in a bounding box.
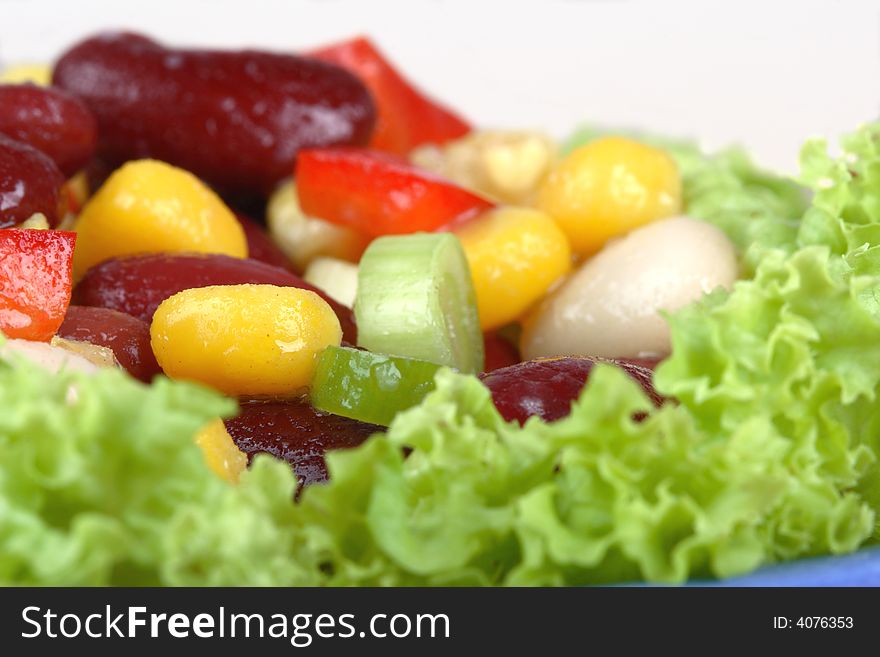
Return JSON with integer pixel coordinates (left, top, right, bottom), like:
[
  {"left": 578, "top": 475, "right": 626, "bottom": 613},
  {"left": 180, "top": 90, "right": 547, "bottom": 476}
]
[{"left": 150, "top": 285, "right": 342, "bottom": 395}]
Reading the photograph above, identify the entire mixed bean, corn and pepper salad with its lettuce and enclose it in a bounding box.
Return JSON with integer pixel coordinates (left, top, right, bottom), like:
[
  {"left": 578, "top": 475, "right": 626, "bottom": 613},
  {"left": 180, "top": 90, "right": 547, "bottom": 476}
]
[{"left": 0, "top": 33, "right": 880, "bottom": 586}]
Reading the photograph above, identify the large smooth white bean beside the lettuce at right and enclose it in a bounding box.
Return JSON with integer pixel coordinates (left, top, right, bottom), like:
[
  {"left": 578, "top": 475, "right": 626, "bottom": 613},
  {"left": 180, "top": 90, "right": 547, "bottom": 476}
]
[{"left": 521, "top": 217, "right": 737, "bottom": 358}]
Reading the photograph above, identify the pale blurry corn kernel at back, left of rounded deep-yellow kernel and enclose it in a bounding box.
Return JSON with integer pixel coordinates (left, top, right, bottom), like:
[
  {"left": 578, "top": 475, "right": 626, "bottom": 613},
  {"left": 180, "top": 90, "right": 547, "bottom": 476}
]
[{"left": 410, "top": 130, "right": 556, "bottom": 205}]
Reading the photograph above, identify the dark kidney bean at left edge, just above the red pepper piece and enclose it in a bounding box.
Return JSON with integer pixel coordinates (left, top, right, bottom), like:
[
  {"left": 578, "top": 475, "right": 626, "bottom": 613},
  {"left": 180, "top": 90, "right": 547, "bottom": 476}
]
[{"left": 0, "top": 134, "right": 64, "bottom": 228}]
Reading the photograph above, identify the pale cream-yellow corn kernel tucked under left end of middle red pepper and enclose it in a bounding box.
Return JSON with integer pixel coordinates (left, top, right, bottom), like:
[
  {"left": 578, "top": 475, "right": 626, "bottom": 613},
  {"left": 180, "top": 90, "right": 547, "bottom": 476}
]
[{"left": 266, "top": 180, "right": 369, "bottom": 271}]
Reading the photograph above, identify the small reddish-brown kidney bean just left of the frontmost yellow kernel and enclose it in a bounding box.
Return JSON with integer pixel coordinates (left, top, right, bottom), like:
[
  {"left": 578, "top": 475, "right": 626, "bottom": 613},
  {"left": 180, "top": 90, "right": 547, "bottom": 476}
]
[{"left": 58, "top": 306, "right": 162, "bottom": 383}]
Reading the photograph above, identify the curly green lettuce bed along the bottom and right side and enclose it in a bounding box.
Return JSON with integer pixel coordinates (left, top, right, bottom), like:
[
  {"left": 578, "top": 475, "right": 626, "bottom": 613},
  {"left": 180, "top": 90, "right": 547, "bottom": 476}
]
[{"left": 0, "top": 115, "right": 880, "bottom": 586}]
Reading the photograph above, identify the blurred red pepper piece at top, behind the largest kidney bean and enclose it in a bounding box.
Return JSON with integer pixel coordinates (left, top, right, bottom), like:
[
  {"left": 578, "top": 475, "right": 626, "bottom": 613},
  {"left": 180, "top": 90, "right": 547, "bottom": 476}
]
[{"left": 306, "top": 37, "right": 471, "bottom": 155}]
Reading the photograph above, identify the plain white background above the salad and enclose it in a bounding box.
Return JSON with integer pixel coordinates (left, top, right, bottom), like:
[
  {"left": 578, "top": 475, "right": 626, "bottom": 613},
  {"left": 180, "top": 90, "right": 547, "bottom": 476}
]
[{"left": 0, "top": 0, "right": 880, "bottom": 171}]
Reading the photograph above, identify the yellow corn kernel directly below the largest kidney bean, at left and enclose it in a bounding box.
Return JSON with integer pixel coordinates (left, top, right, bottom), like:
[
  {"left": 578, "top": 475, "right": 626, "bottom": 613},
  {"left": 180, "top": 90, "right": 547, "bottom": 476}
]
[{"left": 73, "top": 160, "right": 247, "bottom": 278}]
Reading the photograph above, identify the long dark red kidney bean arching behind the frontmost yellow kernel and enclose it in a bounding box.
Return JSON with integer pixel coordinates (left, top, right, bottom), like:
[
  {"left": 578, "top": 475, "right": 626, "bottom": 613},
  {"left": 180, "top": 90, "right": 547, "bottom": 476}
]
[{"left": 73, "top": 253, "right": 357, "bottom": 343}]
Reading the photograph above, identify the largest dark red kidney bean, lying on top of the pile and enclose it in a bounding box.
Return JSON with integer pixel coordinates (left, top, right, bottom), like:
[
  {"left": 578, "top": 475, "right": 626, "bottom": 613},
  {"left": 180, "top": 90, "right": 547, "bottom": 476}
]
[{"left": 54, "top": 33, "right": 376, "bottom": 193}]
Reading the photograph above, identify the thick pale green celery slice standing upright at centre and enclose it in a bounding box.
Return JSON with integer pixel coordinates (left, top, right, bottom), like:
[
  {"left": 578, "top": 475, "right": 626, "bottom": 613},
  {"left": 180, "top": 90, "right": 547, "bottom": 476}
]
[{"left": 354, "top": 233, "right": 483, "bottom": 373}]
